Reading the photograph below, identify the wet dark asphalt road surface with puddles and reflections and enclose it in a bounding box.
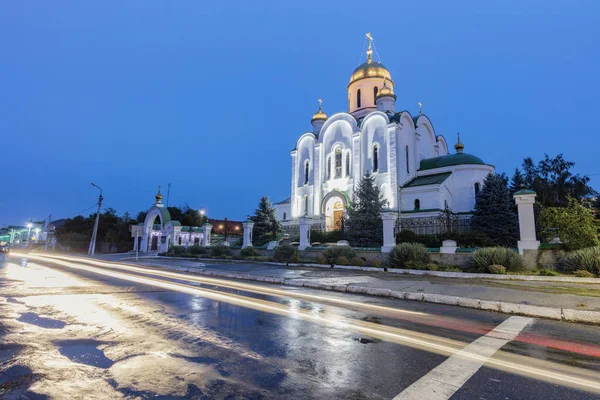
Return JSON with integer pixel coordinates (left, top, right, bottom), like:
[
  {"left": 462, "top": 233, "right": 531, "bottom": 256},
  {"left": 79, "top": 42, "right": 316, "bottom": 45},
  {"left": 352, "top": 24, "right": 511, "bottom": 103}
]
[{"left": 0, "top": 256, "right": 600, "bottom": 399}]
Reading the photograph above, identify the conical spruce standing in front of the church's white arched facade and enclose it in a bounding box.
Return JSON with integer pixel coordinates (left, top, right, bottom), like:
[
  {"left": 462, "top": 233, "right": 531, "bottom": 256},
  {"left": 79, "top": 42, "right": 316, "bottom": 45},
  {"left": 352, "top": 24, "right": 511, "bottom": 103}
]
[{"left": 345, "top": 174, "right": 386, "bottom": 247}]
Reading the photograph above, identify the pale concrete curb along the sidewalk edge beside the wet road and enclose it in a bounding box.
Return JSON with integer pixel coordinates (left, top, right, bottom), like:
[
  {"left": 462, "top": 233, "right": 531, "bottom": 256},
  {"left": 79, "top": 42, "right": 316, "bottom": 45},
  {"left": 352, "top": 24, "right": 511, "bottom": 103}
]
[{"left": 131, "top": 265, "right": 600, "bottom": 325}]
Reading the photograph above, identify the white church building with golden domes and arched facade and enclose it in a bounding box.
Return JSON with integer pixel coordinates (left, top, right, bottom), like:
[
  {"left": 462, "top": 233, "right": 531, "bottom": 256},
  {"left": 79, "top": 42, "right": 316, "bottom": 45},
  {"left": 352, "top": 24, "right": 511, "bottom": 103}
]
[{"left": 274, "top": 34, "right": 494, "bottom": 231}]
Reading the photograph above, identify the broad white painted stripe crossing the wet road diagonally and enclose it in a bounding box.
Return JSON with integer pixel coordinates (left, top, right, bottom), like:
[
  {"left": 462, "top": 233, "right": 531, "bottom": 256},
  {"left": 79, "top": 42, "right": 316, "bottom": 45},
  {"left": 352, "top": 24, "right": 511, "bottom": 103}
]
[{"left": 394, "top": 317, "right": 533, "bottom": 400}]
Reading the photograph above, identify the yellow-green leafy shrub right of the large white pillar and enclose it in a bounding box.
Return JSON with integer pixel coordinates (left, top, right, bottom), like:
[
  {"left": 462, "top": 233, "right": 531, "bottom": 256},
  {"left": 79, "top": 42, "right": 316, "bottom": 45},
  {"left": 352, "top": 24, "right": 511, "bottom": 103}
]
[{"left": 541, "top": 199, "right": 599, "bottom": 250}]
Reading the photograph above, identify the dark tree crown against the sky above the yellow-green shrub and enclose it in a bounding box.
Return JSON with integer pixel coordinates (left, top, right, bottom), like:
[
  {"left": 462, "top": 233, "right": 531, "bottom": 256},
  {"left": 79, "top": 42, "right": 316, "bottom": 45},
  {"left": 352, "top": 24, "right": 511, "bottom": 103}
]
[{"left": 511, "top": 154, "right": 595, "bottom": 207}]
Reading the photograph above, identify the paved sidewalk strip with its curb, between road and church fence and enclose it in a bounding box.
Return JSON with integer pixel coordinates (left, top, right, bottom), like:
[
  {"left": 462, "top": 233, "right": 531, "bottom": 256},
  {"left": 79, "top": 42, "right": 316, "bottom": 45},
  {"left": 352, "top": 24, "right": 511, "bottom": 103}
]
[{"left": 123, "top": 258, "right": 600, "bottom": 324}]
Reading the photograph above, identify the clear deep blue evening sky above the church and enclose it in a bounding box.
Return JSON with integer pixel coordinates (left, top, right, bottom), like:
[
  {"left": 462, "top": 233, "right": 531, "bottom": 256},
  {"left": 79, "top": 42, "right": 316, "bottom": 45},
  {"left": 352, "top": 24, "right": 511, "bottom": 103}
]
[{"left": 0, "top": 0, "right": 600, "bottom": 226}]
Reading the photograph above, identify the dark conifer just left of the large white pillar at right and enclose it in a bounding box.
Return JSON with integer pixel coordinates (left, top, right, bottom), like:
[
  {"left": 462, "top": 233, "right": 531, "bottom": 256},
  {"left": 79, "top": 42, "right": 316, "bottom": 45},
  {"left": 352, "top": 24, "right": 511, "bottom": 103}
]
[{"left": 471, "top": 174, "right": 518, "bottom": 246}]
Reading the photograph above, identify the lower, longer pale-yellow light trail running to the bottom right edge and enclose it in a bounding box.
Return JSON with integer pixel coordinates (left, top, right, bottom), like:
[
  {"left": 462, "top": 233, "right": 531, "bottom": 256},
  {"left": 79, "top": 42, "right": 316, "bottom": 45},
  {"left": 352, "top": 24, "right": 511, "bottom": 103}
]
[{"left": 15, "top": 253, "right": 600, "bottom": 394}]
